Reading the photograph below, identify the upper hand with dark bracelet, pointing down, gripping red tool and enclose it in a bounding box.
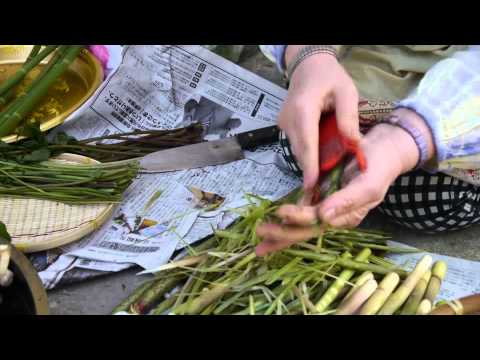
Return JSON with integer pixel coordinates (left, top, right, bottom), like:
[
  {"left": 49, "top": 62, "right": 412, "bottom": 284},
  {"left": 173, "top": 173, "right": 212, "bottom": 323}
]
[{"left": 278, "top": 45, "right": 361, "bottom": 193}]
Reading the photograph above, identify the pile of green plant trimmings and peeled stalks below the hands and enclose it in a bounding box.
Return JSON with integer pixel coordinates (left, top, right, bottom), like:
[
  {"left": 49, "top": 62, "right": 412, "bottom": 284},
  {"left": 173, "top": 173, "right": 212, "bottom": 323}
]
[{"left": 113, "top": 191, "right": 446, "bottom": 315}]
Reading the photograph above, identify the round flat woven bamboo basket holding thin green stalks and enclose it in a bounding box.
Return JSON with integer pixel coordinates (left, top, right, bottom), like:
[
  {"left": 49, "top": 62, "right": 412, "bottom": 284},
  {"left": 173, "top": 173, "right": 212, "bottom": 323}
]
[{"left": 0, "top": 154, "right": 114, "bottom": 253}]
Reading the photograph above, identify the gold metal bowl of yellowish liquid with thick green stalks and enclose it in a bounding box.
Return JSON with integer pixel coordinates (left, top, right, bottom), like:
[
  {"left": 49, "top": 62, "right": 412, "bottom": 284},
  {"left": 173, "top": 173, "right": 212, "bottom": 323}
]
[{"left": 0, "top": 45, "right": 104, "bottom": 143}]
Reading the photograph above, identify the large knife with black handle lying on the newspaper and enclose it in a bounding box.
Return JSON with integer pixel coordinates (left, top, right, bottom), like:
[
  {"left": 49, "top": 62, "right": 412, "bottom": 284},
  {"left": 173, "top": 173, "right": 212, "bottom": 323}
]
[{"left": 140, "top": 126, "right": 279, "bottom": 173}]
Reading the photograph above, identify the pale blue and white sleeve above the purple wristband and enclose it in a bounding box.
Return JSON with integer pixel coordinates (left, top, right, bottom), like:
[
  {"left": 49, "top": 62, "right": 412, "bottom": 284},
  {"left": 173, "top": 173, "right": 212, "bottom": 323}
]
[{"left": 398, "top": 46, "right": 480, "bottom": 171}]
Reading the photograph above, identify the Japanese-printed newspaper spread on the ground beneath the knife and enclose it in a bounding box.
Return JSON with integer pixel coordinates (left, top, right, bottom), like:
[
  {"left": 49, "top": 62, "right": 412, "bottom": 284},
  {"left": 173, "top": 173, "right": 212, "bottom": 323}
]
[{"left": 40, "top": 45, "right": 300, "bottom": 288}]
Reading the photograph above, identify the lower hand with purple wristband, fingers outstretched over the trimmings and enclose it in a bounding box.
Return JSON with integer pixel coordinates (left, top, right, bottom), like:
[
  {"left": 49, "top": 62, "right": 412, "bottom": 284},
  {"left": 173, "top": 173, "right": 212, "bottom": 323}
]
[{"left": 256, "top": 109, "right": 434, "bottom": 256}]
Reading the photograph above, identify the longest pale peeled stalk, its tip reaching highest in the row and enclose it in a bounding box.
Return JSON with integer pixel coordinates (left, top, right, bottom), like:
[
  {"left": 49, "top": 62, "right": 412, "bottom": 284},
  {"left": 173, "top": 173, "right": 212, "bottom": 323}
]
[{"left": 378, "top": 255, "right": 432, "bottom": 315}]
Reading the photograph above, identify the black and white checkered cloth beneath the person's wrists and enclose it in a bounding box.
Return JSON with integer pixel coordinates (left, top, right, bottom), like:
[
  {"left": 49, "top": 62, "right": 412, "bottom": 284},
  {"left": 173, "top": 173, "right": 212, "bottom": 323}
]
[{"left": 280, "top": 132, "right": 480, "bottom": 234}]
